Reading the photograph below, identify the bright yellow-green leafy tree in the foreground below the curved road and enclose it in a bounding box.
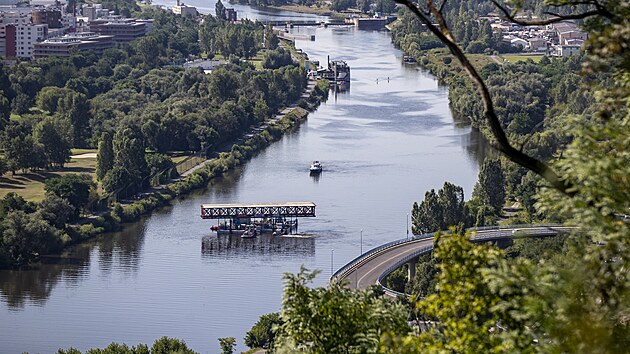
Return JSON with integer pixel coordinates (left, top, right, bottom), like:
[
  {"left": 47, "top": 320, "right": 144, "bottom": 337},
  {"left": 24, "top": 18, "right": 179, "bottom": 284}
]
[{"left": 381, "top": 234, "right": 544, "bottom": 354}]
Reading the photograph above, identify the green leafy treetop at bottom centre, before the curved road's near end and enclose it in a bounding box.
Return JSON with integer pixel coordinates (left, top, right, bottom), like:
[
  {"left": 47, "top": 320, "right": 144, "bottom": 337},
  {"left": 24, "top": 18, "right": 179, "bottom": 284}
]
[{"left": 275, "top": 268, "right": 409, "bottom": 353}]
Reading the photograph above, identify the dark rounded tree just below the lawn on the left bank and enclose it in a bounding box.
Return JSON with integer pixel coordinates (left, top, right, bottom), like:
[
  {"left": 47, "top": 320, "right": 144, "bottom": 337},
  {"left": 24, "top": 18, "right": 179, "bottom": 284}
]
[{"left": 44, "top": 173, "right": 95, "bottom": 217}]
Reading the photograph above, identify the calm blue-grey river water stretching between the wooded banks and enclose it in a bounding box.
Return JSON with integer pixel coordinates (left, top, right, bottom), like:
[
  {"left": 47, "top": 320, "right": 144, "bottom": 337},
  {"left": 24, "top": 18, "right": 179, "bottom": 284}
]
[{"left": 0, "top": 3, "right": 484, "bottom": 353}]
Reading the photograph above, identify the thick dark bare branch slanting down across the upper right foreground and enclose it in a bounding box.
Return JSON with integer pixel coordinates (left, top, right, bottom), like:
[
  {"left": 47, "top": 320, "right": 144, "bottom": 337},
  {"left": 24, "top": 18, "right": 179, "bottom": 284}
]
[{"left": 396, "top": 0, "right": 576, "bottom": 197}]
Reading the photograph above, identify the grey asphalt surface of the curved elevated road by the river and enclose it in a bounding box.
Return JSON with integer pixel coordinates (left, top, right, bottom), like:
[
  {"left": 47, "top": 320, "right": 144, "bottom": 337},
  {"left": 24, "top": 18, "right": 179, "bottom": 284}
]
[{"left": 337, "top": 225, "right": 574, "bottom": 289}]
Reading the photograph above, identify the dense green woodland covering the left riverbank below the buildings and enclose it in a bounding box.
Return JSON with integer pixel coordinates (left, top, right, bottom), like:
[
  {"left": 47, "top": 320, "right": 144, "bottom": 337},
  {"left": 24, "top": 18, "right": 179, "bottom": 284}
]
[{"left": 0, "top": 6, "right": 316, "bottom": 267}]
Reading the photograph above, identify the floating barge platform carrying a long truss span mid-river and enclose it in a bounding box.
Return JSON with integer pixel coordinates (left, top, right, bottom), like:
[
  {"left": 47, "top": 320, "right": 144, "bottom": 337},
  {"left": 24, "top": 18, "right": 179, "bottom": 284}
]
[{"left": 201, "top": 202, "right": 316, "bottom": 235}]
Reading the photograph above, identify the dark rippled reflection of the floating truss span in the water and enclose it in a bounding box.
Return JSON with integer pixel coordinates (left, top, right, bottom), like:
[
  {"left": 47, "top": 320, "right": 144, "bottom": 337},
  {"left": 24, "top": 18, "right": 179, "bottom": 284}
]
[{"left": 201, "top": 233, "right": 315, "bottom": 258}]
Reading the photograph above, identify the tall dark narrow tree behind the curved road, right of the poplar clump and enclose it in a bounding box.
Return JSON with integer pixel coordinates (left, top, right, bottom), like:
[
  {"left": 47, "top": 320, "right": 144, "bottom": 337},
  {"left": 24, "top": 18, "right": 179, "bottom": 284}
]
[{"left": 473, "top": 159, "right": 505, "bottom": 215}]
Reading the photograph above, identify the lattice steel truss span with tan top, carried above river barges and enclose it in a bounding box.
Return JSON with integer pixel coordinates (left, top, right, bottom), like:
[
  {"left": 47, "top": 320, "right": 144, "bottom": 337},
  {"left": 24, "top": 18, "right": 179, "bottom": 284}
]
[{"left": 201, "top": 202, "right": 316, "bottom": 219}]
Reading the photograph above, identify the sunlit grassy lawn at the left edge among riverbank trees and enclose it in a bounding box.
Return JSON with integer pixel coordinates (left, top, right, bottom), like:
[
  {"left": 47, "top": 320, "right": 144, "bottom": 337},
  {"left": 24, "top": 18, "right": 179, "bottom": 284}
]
[{"left": 0, "top": 158, "right": 96, "bottom": 201}]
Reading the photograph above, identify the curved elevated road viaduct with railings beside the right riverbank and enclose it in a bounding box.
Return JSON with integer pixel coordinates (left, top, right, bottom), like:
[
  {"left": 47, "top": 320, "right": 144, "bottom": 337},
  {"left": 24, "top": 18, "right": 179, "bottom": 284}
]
[{"left": 331, "top": 225, "right": 576, "bottom": 297}]
